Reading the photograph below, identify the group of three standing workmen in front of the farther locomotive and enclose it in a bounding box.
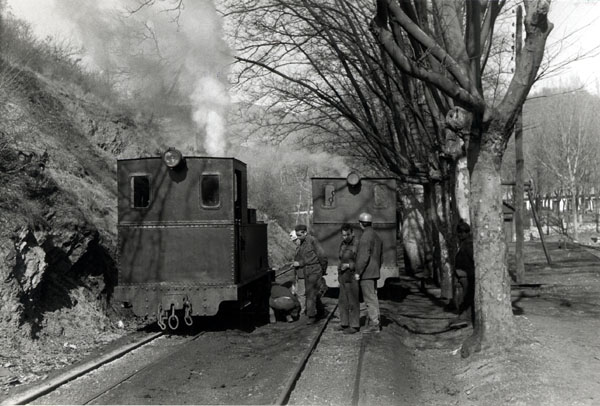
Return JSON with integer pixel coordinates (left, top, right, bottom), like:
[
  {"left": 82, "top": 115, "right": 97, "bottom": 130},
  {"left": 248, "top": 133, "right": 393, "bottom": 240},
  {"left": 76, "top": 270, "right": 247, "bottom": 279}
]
[{"left": 293, "top": 213, "right": 383, "bottom": 334}]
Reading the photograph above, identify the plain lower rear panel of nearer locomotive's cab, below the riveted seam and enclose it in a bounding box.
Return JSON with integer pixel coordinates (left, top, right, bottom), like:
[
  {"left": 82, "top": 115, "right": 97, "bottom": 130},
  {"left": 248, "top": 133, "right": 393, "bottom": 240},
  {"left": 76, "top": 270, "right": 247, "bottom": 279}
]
[{"left": 119, "top": 225, "right": 235, "bottom": 284}]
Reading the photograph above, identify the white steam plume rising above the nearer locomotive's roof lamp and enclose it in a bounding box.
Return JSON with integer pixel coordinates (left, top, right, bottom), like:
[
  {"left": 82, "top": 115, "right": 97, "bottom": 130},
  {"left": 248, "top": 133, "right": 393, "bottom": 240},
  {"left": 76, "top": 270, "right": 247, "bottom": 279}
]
[{"left": 48, "top": 0, "right": 231, "bottom": 155}]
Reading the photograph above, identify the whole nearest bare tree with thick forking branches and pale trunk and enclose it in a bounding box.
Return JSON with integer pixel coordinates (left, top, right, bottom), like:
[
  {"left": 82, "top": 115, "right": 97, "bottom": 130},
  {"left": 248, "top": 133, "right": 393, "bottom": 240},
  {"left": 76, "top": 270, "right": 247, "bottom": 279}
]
[{"left": 373, "top": 0, "right": 552, "bottom": 356}]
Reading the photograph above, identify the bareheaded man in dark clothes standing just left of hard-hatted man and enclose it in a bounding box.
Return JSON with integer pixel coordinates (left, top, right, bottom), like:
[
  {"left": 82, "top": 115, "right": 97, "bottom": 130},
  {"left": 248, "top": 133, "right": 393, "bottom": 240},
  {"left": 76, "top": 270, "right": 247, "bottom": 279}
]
[{"left": 338, "top": 224, "right": 360, "bottom": 334}]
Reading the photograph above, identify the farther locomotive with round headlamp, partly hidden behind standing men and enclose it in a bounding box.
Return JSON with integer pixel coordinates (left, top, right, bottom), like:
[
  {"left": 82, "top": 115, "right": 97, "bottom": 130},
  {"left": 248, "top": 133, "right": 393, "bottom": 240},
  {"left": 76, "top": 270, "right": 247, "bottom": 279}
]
[{"left": 312, "top": 178, "right": 398, "bottom": 287}]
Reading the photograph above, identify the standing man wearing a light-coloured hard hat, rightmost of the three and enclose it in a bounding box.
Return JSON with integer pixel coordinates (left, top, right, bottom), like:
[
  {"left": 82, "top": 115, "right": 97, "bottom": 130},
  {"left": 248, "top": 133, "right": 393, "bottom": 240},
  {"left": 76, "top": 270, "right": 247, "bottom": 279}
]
[{"left": 355, "top": 213, "right": 383, "bottom": 332}]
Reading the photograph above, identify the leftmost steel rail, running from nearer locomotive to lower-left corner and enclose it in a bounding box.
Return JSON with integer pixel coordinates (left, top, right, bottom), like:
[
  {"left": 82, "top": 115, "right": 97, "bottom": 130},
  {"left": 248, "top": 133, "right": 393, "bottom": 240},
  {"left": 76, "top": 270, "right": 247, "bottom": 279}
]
[{"left": 0, "top": 332, "right": 163, "bottom": 406}]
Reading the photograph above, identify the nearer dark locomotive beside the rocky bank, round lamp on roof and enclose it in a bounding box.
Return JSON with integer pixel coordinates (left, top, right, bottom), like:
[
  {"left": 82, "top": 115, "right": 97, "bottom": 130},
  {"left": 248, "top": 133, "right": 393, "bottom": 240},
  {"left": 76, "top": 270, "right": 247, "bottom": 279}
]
[{"left": 114, "top": 149, "right": 271, "bottom": 329}]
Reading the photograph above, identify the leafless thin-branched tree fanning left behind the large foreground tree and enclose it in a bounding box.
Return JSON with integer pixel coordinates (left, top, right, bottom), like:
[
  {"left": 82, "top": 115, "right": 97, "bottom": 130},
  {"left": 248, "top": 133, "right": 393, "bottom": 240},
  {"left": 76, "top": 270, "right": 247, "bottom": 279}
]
[{"left": 222, "top": 0, "right": 454, "bottom": 297}]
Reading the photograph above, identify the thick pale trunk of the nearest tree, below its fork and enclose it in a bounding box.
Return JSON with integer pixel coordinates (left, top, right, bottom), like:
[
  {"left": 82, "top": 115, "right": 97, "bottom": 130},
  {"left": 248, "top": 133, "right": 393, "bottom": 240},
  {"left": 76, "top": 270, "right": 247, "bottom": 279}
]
[{"left": 461, "top": 142, "right": 515, "bottom": 356}]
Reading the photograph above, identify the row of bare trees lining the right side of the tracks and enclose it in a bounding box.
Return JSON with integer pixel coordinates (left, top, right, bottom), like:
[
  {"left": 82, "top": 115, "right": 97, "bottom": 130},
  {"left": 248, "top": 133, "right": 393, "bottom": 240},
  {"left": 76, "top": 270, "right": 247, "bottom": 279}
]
[{"left": 216, "top": 0, "right": 552, "bottom": 354}]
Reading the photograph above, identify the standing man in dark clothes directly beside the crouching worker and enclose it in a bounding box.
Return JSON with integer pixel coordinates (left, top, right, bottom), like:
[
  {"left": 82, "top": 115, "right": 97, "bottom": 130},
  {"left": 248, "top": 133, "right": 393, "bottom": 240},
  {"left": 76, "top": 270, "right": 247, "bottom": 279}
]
[{"left": 293, "top": 224, "right": 327, "bottom": 324}]
